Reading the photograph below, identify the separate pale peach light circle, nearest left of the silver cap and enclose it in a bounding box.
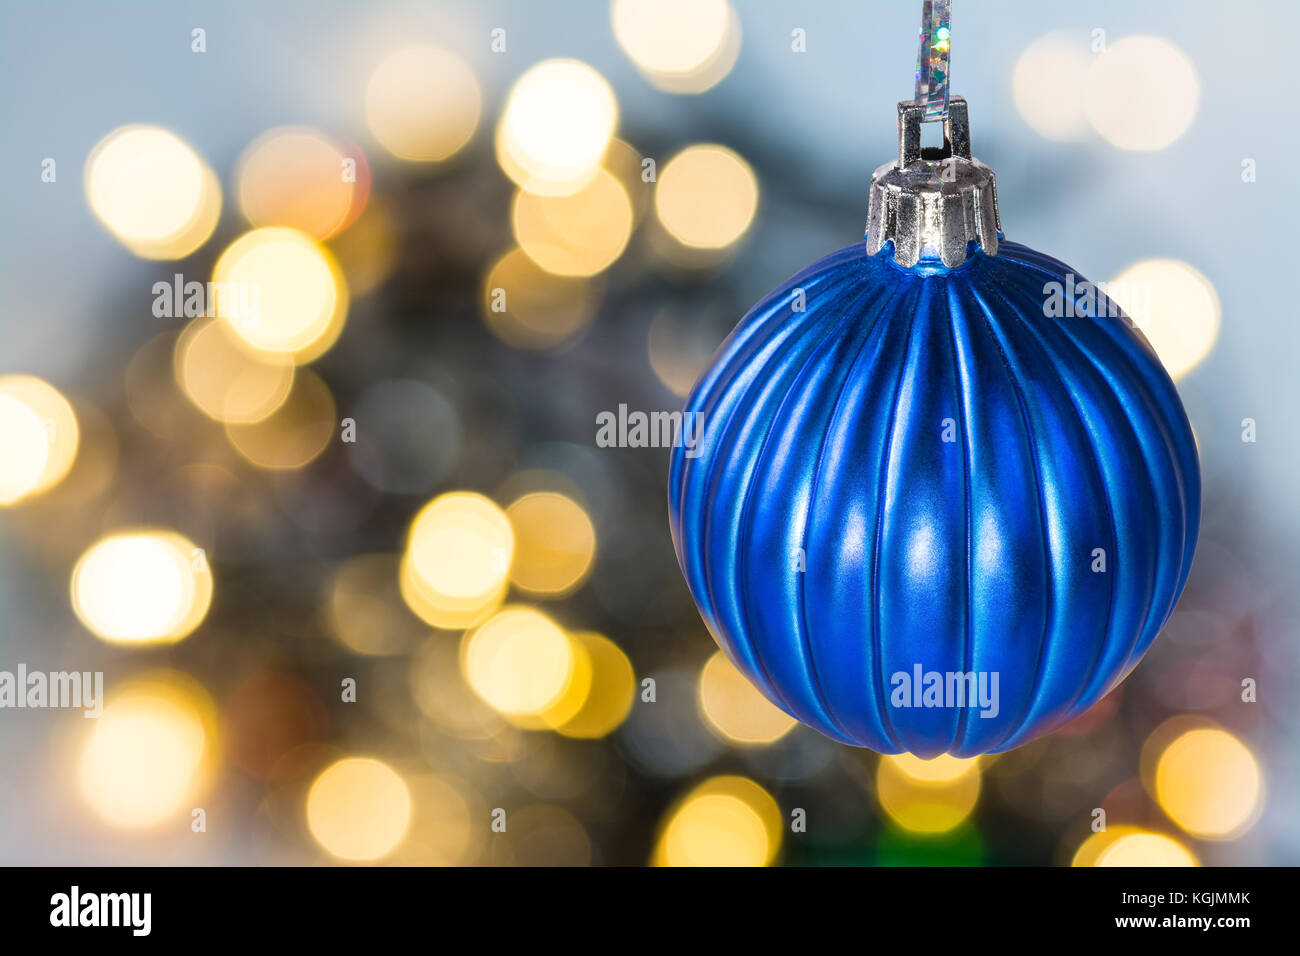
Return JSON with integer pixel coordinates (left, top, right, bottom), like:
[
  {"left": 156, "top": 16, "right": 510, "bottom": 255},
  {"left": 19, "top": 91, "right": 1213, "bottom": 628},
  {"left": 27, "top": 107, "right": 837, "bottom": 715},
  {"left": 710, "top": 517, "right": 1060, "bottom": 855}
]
[{"left": 654, "top": 143, "right": 758, "bottom": 250}]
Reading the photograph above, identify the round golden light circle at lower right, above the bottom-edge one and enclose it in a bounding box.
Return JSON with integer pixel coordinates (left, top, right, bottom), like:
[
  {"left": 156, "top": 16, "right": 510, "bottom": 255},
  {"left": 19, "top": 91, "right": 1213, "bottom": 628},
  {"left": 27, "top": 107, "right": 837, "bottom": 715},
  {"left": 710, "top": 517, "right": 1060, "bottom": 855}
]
[{"left": 1154, "top": 727, "right": 1264, "bottom": 840}]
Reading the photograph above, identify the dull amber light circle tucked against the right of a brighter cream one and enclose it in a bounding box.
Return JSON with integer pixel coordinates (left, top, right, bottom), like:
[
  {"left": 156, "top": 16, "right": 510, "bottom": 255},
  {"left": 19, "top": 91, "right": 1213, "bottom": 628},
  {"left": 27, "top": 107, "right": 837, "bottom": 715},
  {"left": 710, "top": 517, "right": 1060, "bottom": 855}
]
[{"left": 506, "top": 492, "right": 595, "bottom": 596}]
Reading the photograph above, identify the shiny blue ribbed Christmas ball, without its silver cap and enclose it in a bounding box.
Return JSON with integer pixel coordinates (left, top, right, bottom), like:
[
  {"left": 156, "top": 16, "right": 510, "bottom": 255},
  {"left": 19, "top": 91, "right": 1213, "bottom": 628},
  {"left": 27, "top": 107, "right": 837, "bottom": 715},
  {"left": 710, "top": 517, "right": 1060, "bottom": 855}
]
[{"left": 668, "top": 241, "right": 1200, "bottom": 757}]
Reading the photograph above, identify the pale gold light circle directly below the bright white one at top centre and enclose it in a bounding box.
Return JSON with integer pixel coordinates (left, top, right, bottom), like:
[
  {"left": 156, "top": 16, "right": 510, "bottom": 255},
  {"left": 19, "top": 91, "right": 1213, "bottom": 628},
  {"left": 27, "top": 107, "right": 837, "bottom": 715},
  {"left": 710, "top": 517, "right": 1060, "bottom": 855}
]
[{"left": 511, "top": 169, "right": 632, "bottom": 277}]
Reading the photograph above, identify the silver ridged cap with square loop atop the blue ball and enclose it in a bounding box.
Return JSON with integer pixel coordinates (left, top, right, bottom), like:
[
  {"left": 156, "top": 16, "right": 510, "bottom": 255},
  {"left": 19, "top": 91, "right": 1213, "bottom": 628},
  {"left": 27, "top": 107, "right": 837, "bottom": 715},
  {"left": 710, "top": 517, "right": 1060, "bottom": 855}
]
[{"left": 867, "top": 96, "right": 1002, "bottom": 269}]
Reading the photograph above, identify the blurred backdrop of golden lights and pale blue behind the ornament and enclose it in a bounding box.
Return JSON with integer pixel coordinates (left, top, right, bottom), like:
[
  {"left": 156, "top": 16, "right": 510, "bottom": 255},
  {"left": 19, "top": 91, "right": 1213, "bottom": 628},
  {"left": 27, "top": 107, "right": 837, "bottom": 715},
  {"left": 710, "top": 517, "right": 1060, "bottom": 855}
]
[{"left": 0, "top": 0, "right": 1300, "bottom": 865}]
